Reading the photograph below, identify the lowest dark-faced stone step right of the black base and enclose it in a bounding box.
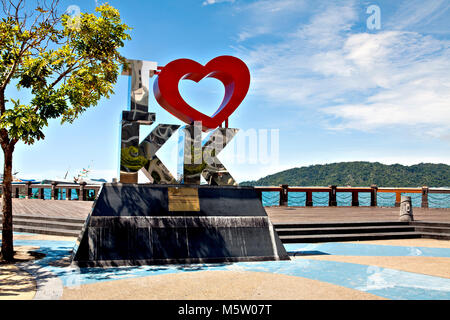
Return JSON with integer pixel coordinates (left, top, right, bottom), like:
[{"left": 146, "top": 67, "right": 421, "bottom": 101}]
[{"left": 280, "top": 232, "right": 422, "bottom": 243}]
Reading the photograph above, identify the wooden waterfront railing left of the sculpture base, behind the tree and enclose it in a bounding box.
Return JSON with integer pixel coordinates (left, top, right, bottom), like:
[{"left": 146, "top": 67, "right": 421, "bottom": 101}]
[{"left": 0, "top": 182, "right": 101, "bottom": 201}]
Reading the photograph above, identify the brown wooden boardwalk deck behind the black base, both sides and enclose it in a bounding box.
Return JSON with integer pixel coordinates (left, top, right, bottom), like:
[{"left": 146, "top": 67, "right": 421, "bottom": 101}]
[{"left": 0, "top": 199, "right": 450, "bottom": 223}]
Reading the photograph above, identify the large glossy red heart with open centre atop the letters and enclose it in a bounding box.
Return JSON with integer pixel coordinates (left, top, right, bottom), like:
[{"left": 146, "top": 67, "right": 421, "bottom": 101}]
[{"left": 153, "top": 56, "right": 250, "bottom": 131}]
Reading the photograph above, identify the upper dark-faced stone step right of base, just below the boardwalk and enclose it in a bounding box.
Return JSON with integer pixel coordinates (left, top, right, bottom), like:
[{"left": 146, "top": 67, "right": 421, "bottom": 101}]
[{"left": 275, "top": 225, "right": 414, "bottom": 236}]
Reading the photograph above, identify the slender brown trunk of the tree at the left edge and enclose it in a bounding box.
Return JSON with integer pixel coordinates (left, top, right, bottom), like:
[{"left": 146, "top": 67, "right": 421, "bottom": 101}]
[{"left": 2, "top": 146, "right": 14, "bottom": 261}]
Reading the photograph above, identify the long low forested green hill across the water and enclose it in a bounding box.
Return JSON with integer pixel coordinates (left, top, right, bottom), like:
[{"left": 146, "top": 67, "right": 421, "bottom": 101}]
[{"left": 240, "top": 161, "right": 450, "bottom": 187}]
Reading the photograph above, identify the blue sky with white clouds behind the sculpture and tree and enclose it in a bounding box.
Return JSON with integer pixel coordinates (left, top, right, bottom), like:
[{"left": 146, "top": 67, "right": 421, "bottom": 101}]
[{"left": 3, "top": 0, "right": 450, "bottom": 182}]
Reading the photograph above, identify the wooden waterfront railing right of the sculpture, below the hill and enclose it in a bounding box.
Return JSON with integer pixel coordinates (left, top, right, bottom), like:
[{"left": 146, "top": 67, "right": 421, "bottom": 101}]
[{"left": 255, "top": 184, "right": 450, "bottom": 208}]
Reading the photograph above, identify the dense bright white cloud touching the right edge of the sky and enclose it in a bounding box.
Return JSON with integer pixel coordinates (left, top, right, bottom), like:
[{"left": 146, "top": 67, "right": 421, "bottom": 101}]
[{"left": 324, "top": 31, "right": 450, "bottom": 133}]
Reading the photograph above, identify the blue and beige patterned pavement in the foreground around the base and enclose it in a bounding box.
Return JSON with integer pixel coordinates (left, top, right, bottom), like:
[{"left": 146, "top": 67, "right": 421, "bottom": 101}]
[{"left": 0, "top": 233, "right": 450, "bottom": 300}]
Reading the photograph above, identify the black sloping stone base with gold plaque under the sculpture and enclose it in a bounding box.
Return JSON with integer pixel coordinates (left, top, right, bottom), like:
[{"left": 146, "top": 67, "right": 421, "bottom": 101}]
[{"left": 72, "top": 183, "right": 289, "bottom": 267}]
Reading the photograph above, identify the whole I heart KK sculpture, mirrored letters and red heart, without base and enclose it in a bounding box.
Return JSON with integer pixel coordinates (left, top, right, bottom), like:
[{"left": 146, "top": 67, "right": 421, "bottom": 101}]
[{"left": 120, "top": 56, "right": 250, "bottom": 185}]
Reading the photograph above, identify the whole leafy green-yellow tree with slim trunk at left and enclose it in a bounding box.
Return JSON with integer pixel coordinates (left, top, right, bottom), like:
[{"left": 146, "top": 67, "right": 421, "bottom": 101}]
[{"left": 0, "top": 0, "right": 131, "bottom": 261}]
